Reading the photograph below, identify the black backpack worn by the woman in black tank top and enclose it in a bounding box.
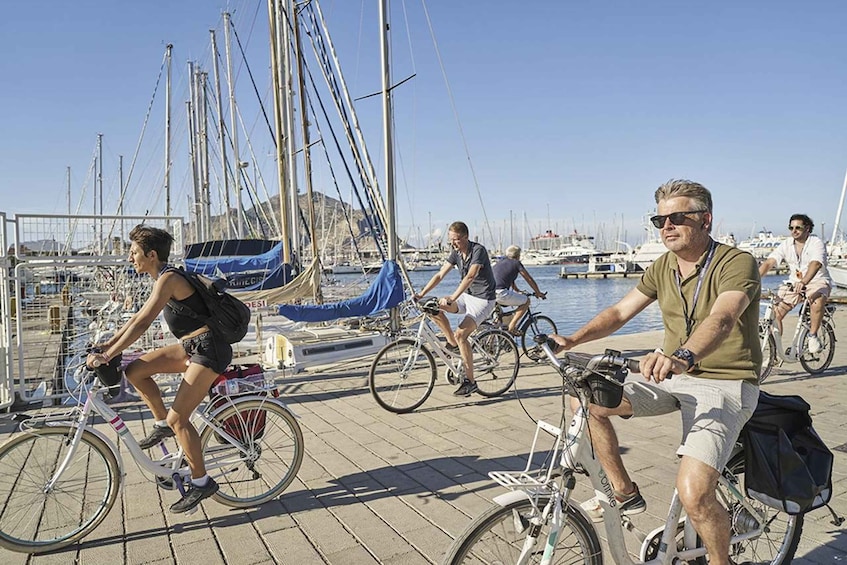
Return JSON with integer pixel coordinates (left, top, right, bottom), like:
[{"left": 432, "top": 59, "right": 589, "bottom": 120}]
[{"left": 168, "top": 267, "right": 250, "bottom": 343}]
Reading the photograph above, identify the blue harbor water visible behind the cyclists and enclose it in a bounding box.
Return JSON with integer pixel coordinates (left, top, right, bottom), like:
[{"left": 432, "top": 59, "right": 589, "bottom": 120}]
[{"left": 335, "top": 265, "right": 800, "bottom": 335}]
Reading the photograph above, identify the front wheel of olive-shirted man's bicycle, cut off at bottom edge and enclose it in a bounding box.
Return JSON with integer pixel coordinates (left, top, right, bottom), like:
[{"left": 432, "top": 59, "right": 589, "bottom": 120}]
[{"left": 444, "top": 498, "right": 603, "bottom": 565}]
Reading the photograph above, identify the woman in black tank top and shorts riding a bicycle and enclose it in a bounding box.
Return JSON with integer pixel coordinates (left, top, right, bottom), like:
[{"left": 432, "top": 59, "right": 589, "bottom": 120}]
[{"left": 87, "top": 225, "right": 232, "bottom": 513}]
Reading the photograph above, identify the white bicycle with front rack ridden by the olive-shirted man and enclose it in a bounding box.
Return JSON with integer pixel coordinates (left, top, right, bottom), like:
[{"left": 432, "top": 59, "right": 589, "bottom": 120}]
[{"left": 444, "top": 336, "right": 803, "bottom": 565}]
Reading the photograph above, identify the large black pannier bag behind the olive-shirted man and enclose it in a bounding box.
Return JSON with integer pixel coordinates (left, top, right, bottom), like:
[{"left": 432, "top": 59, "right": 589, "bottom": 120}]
[{"left": 741, "top": 391, "right": 833, "bottom": 514}]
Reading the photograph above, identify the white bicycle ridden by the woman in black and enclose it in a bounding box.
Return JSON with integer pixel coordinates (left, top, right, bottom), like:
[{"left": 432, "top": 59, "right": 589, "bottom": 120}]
[{"left": 0, "top": 364, "right": 304, "bottom": 553}]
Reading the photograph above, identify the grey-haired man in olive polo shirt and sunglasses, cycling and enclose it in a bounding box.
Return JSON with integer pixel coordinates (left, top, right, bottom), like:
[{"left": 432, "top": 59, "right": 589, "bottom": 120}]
[{"left": 554, "top": 180, "right": 762, "bottom": 565}]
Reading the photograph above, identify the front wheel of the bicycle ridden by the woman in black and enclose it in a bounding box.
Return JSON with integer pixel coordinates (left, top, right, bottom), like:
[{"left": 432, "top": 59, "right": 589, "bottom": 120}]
[{"left": 0, "top": 426, "right": 121, "bottom": 553}]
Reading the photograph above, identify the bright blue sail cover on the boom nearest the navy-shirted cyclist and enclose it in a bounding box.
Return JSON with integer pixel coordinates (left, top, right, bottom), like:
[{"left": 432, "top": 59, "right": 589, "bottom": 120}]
[{"left": 279, "top": 261, "right": 405, "bottom": 322}]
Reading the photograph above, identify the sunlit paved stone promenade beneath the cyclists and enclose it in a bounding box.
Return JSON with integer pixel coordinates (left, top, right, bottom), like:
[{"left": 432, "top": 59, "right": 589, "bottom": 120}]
[{"left": 0, "top": 311, "right": 847, "bottom": 565}]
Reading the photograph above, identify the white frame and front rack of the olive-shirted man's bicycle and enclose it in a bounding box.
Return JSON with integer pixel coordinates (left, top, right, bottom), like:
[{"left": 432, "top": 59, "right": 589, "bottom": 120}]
[{"left": 489, "top": 345, "right": 765, "bottom": 565}]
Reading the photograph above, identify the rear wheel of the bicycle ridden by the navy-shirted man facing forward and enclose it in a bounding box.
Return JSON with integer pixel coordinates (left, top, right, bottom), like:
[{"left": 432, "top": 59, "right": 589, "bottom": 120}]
[{"left": 473, "top": 329, "right": 520, "bottom": 396}]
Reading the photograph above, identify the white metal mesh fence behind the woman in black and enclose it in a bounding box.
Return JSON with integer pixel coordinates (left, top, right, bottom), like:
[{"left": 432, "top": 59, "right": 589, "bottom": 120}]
[{"left": 0, "top": 213, "right": 184, "bottom": 408}]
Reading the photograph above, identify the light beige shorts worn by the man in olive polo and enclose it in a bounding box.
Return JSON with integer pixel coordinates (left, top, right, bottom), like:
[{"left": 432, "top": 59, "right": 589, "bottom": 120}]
[{"left": 624, "top": 375, "right": 759, "bottom": 471}]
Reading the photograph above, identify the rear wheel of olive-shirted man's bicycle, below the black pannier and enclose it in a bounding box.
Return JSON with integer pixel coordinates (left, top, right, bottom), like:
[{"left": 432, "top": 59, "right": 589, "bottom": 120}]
[{"left": 717, "top": 453, "right": 803, "bottom": 565}]
